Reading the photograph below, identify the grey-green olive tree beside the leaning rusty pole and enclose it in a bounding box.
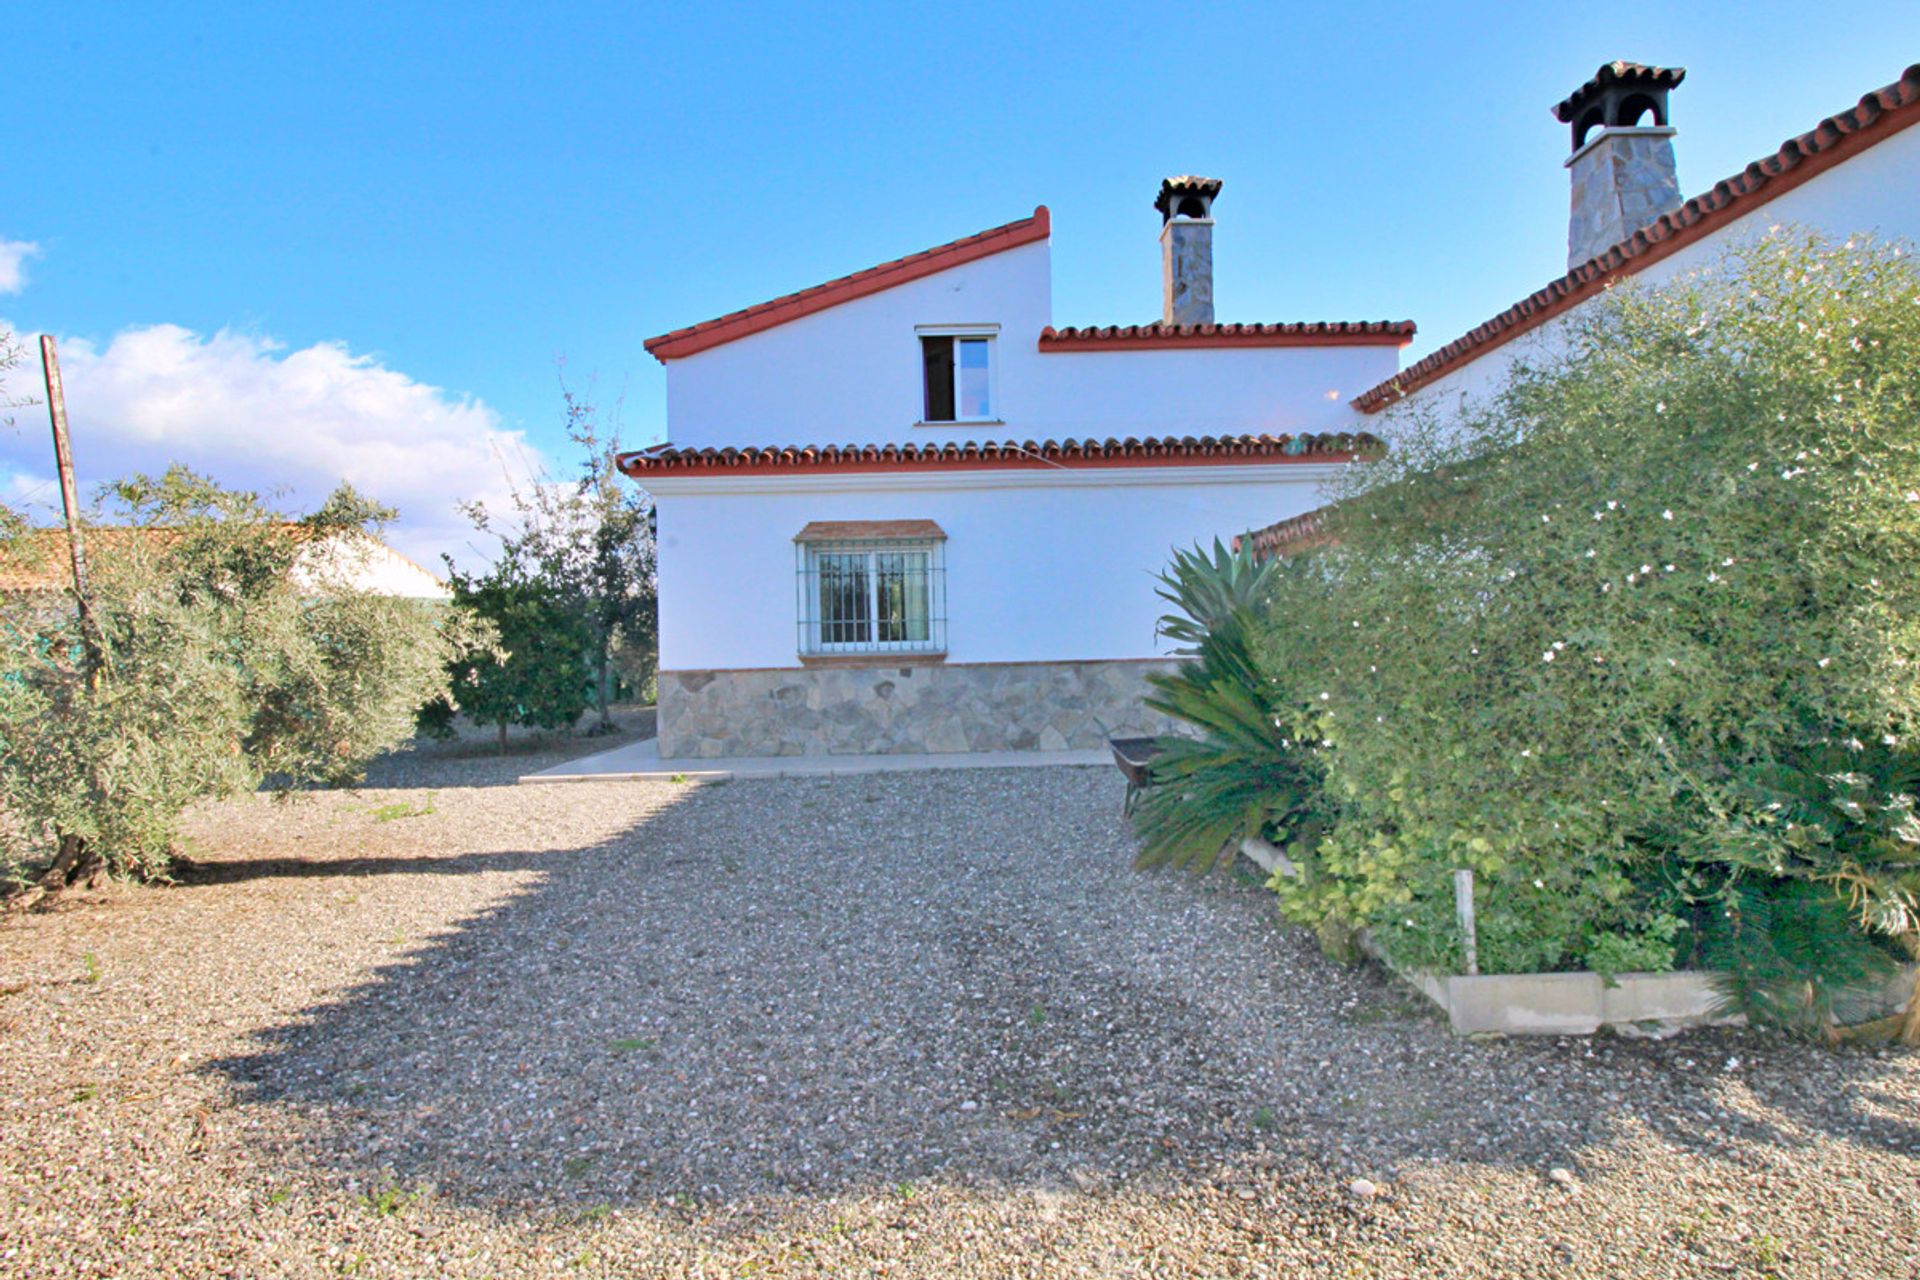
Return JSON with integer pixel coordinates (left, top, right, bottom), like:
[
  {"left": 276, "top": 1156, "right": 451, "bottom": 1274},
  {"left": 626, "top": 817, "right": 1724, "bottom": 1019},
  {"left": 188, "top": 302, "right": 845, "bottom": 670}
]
[{"left": 0, "top": 466, "right": 459, "bottom": 889}]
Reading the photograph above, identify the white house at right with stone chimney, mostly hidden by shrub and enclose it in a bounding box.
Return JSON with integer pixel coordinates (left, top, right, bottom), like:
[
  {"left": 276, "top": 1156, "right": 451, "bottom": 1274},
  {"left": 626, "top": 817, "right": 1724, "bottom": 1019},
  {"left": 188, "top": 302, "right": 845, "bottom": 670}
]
[{"left": 1252, "top": 61, "right": 1920, "bottom": 553}]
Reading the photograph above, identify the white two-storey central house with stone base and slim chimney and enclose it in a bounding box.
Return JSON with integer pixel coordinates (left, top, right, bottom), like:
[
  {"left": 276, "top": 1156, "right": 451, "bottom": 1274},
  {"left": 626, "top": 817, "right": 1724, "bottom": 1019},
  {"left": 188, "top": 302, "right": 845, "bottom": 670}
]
[{"left": 622, "top": 177, "right": 1413, "bottom": 758}]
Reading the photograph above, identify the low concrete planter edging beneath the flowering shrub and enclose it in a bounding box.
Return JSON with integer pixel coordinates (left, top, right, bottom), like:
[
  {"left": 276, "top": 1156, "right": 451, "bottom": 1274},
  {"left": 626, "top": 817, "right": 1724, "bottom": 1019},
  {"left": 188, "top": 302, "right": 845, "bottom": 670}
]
[{"left": 1240, "top": 841, "right": 1914, "bottom": 1036}]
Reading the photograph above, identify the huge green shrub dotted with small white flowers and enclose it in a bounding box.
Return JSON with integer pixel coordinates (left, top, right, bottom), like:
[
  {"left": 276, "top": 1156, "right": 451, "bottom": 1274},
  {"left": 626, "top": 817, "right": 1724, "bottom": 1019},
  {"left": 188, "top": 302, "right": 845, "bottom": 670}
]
[{"left": 1256, "top": 232, "right": 1920, "bottom": 1028}]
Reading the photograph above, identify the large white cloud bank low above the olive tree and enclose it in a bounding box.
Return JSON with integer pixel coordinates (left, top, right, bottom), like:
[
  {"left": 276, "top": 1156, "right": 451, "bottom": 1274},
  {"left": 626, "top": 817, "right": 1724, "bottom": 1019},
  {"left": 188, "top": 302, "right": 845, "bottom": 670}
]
[{"left": 0, "top": 324, "right": 540, "bottom": 572}]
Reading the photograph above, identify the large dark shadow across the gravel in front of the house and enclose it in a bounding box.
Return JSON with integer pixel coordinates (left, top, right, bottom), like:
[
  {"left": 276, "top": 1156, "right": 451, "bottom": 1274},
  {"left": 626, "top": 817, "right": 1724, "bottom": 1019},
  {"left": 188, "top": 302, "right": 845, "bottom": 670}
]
[{"left": 213, "top": 770, "right": 1920, "bottom": 1209}]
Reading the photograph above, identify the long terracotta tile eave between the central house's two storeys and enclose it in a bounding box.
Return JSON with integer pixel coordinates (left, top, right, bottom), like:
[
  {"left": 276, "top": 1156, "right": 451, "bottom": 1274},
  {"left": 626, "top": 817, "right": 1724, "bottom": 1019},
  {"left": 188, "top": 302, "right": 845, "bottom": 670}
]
[{"left": 618, "top": 432, "right": 1380, "bottom": 478}]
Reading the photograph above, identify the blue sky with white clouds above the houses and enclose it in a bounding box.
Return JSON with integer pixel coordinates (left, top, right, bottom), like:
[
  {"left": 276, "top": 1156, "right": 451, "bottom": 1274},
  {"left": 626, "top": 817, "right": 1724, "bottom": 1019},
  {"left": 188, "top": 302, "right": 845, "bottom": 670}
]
[{"left": 0, "top": 2, "right": 1920, "bottom": 557}]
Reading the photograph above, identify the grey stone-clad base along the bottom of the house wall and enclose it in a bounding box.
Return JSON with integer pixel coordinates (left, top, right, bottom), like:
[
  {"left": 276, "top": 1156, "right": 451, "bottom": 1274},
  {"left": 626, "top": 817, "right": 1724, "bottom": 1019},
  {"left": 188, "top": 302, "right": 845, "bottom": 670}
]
[{"left": 659, "top": 658, "right": 1173, "bottom": 760}]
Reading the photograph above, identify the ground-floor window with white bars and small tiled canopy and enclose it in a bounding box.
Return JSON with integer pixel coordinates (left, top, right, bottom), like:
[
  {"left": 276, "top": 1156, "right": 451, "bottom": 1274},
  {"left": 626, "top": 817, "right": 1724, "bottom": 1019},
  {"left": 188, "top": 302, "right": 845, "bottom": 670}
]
[{"left": 795, "top": 520, "right": 947, "bottom": 654}]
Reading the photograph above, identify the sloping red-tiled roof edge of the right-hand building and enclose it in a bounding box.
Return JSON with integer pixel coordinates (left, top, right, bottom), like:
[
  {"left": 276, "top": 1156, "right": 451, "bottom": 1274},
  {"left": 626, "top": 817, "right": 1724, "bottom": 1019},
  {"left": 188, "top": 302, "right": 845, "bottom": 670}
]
[{"left": 1350, "top": 63, "right": 1920, "bottom": 413}]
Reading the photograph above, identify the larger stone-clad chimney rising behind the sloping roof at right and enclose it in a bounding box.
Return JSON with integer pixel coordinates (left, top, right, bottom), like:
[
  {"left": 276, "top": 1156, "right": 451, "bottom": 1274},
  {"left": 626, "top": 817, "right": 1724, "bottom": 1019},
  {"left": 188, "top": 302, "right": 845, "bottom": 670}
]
[{"left": 1553, "top": 61, "right": 1686, "bottom": 271}]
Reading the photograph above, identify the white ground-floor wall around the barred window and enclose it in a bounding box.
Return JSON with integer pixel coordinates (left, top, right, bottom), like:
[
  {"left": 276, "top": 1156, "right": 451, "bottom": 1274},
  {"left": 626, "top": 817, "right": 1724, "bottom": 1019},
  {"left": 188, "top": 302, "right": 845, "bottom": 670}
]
[{"left": 655, "top": 462, "right": 1331, "bottom": 670}]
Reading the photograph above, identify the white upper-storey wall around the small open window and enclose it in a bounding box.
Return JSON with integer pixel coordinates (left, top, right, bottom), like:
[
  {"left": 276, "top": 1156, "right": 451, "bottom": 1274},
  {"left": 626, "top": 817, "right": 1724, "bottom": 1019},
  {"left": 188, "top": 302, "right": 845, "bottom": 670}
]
[{"left": 666, "top": 242, "right": 1400, "bottom": 447}]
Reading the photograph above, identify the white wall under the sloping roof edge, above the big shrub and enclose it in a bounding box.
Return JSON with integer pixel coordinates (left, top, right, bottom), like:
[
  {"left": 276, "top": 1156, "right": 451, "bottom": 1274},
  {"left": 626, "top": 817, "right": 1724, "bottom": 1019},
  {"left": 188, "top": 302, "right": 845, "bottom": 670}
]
[{"left": 1367, "top": 127, "right": 1920, "bottom": 432}]
